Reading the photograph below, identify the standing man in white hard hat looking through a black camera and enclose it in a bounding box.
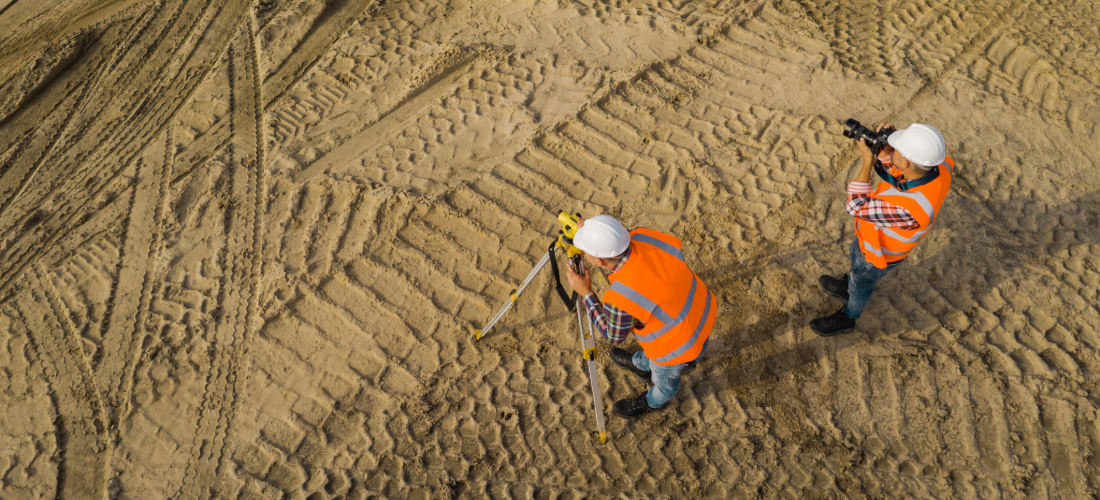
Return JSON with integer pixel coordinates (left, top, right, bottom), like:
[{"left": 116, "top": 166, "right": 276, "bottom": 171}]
[{"left": 810, "top": 123, "right": 955, "bottom": 336}]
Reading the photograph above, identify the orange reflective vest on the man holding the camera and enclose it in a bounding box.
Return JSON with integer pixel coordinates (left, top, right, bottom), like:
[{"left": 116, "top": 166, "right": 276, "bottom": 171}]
[{"left": 858, "top": 158, "right": 955, "bottom": 269}]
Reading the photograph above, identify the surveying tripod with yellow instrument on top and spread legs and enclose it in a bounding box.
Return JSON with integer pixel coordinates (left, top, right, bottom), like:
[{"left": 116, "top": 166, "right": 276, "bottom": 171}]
[{"left": 474, "top": 210, "right": 607, "bottom": 443}]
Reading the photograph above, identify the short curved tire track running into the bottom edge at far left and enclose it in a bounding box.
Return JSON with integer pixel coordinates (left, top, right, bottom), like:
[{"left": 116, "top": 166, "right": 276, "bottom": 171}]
[{"left": 15, "top": 265, "right": 111, "bottom": 498}]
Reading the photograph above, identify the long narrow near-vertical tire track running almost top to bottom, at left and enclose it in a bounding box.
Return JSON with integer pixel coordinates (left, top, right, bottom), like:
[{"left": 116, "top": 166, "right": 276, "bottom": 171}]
[{"left": 179, "top": 18, "right": 264, "bottom": 498}]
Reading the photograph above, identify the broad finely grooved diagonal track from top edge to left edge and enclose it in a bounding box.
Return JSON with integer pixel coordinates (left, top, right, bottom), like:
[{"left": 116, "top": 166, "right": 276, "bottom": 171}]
[{"left": 0, "top": 0, "right": 248, "bottom": 305}]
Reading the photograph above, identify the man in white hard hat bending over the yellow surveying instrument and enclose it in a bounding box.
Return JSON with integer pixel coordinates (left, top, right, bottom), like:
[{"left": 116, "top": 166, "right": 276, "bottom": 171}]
[{"left": 568, "top": 215, "right": 718, "bottom": 418}]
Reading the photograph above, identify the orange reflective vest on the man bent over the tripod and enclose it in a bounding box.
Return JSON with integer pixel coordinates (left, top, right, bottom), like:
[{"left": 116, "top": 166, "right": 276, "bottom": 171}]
[{"left": 604, "top": 229, "right": 718, "bottom": 365}]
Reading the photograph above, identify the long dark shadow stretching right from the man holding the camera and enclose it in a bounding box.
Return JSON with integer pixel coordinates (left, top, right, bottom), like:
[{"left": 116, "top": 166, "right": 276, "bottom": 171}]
[{"left": 857, "top": 184, "right": 1100, "bottom": 334}]
